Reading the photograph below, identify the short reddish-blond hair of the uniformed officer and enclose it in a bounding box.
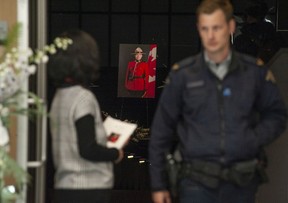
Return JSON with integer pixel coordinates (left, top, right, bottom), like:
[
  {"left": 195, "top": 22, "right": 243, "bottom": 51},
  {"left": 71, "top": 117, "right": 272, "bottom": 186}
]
[{"left": 196, "top": 0, "right": 233, "bottom": 22}]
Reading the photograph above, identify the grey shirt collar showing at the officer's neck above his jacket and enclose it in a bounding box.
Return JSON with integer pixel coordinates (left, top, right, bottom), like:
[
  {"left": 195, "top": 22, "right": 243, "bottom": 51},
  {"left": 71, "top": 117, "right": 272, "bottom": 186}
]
[{"left": 204, "top": 52, "right": 232, "bottom": 80}]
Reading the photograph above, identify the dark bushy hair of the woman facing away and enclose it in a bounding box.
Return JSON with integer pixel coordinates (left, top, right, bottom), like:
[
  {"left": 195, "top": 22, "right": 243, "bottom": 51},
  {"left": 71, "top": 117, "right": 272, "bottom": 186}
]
[{"left": 47, "top": 30, "right": 100, "bottom": 87}]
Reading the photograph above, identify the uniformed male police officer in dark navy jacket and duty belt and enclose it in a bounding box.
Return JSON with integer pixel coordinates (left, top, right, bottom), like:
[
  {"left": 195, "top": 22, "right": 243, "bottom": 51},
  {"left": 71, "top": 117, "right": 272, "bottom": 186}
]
[{"left": 149, "top": 0, "right": 287, "bottom": 203}]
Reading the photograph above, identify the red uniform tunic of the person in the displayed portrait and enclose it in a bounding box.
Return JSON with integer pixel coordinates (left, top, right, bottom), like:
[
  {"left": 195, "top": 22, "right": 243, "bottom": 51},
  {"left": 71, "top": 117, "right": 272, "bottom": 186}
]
[{"left": 125, "top": 61, "right": 149, "bottom": 91}]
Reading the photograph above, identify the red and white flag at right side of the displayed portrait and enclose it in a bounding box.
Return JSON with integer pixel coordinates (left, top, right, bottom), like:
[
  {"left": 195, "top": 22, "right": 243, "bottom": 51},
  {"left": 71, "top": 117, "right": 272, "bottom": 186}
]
[{"left": 145, "top": 44, "right": 157, "bottom": 98}]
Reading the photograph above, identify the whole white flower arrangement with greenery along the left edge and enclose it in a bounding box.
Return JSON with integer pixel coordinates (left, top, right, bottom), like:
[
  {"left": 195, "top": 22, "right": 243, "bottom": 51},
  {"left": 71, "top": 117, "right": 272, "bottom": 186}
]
[{"left": 0, "top": 25, "right": 72, "bottom": 202}]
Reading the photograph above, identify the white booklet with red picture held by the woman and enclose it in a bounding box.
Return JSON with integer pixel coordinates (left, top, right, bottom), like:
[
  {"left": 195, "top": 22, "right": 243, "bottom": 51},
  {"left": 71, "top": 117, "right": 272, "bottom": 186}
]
[{"left": 103, "top": 116, "right": 137, "bottom": 149}]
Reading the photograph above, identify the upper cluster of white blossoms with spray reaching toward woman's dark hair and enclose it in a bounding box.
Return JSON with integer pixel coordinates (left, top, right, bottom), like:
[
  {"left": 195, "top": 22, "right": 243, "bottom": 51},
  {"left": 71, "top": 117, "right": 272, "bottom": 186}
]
[{"left": 0, "top": 35, "right": 72, "bottom": 126}]
